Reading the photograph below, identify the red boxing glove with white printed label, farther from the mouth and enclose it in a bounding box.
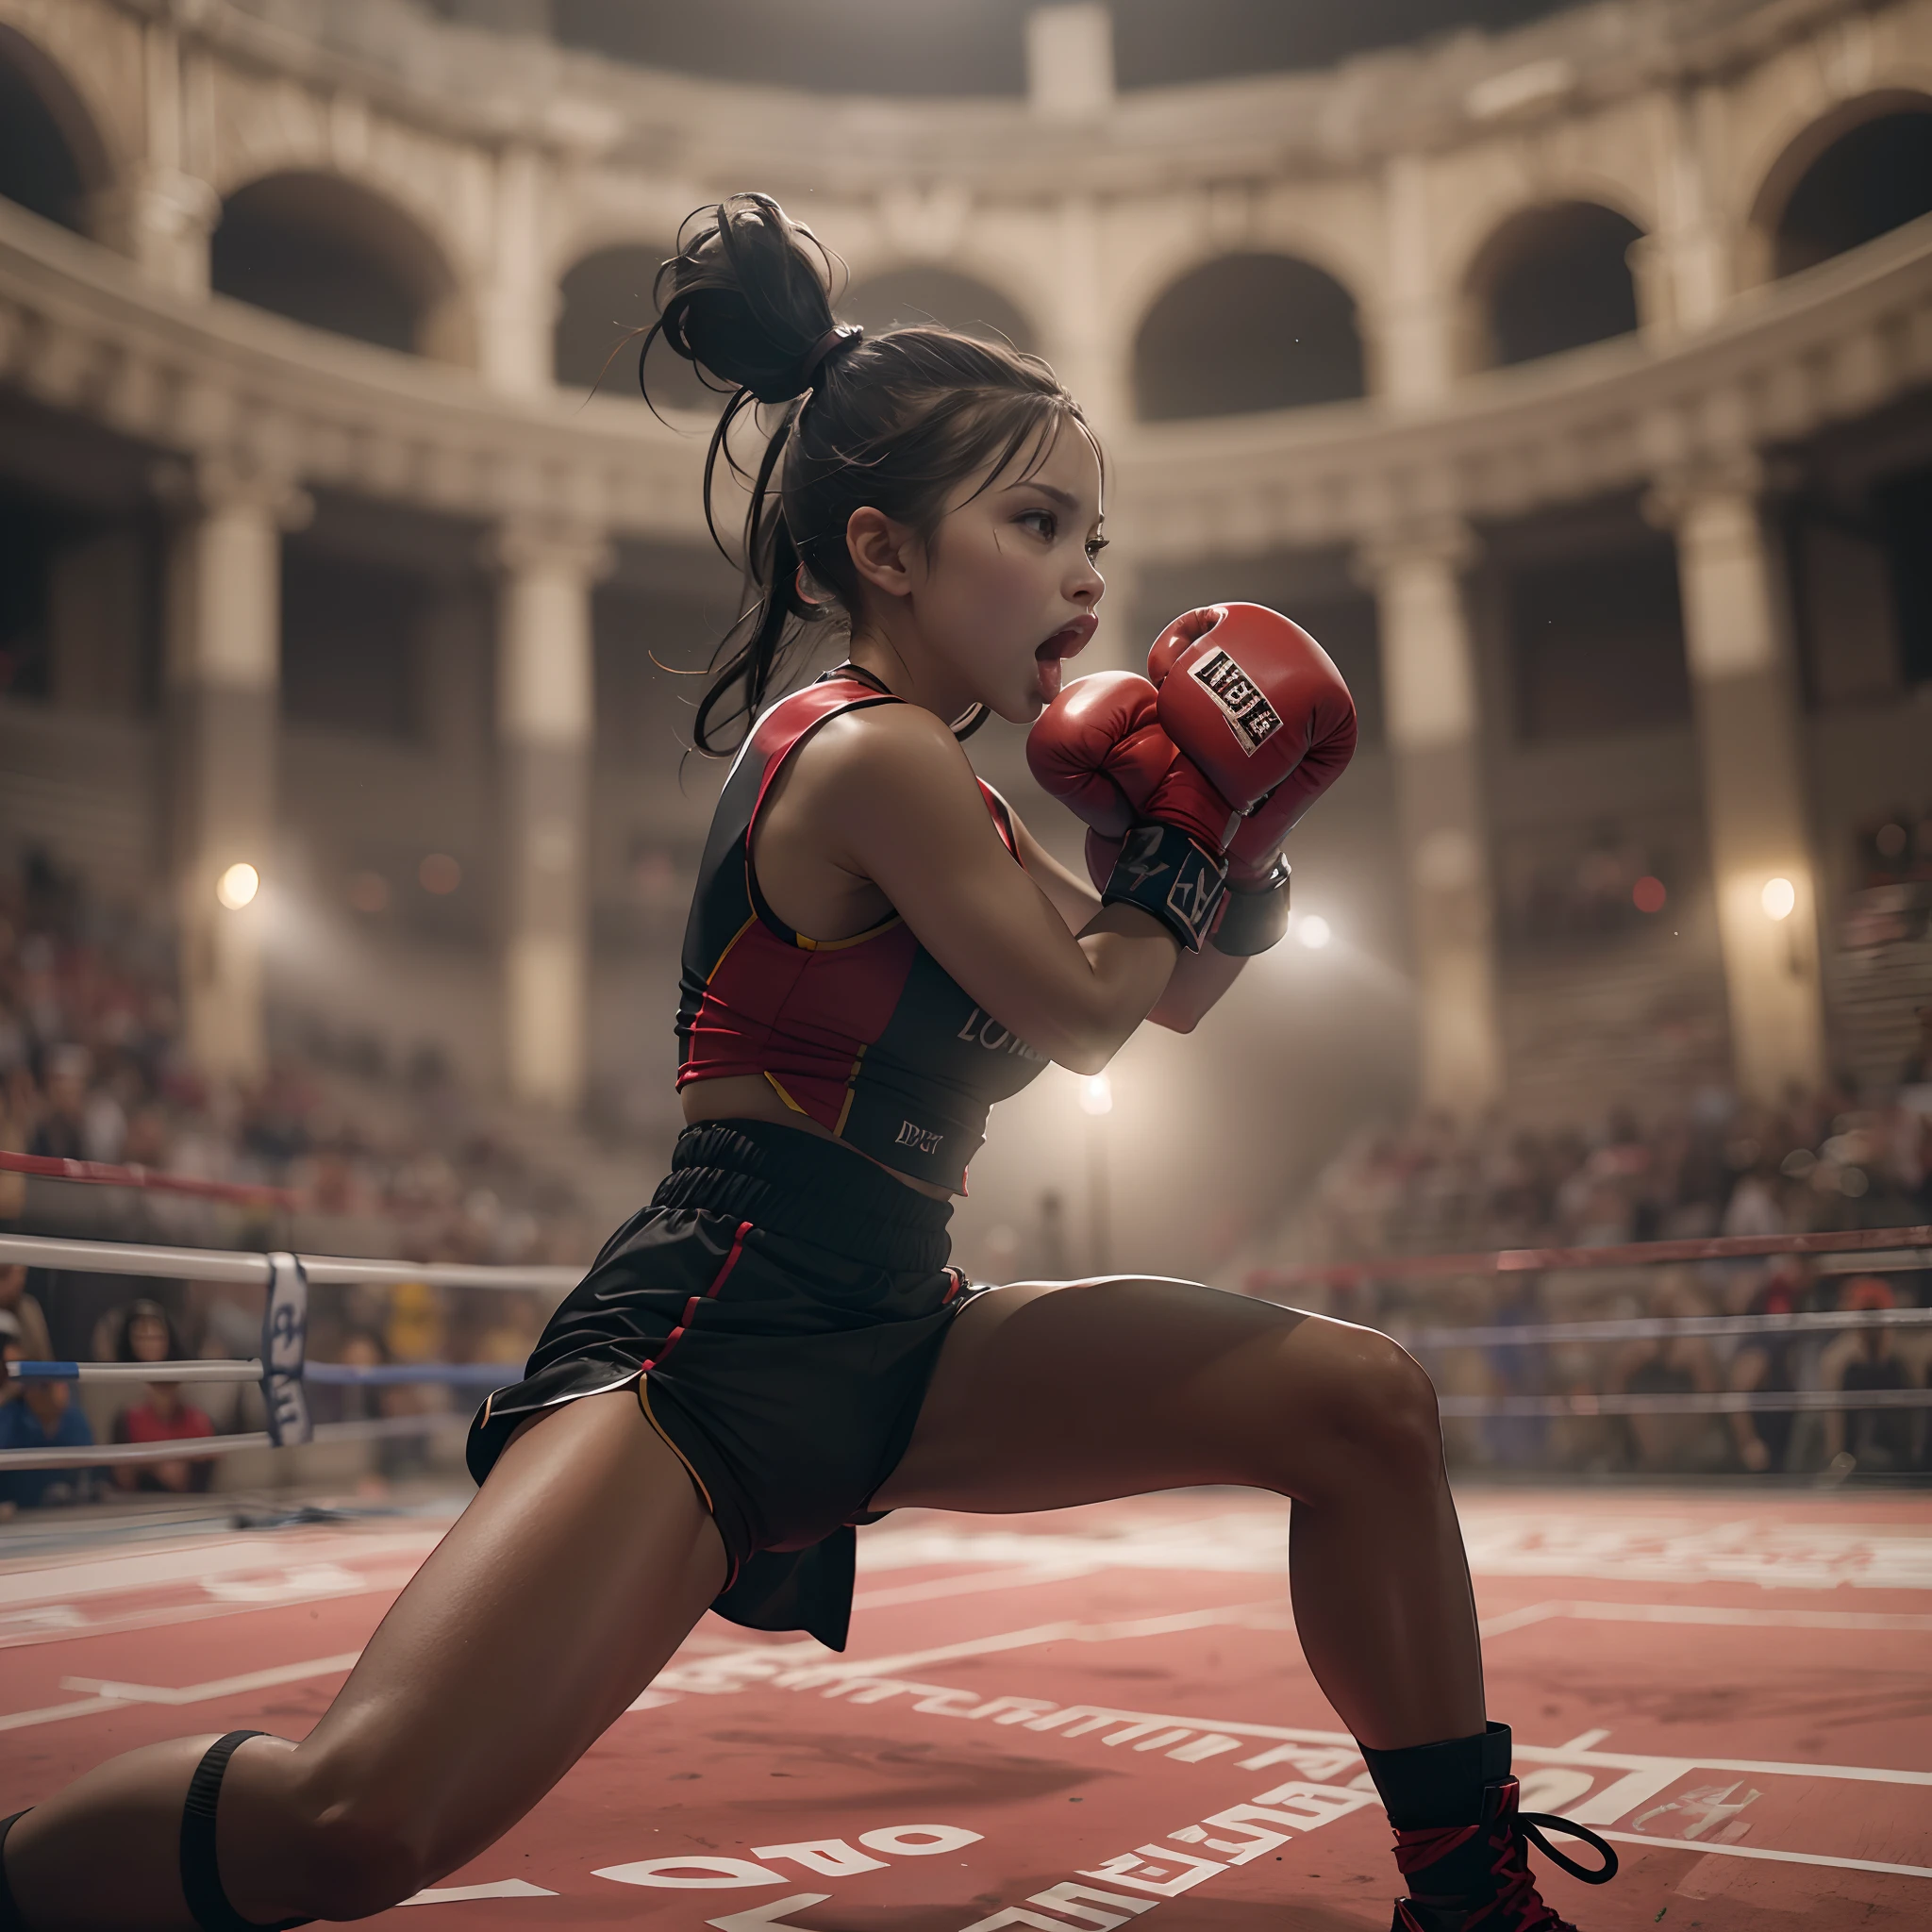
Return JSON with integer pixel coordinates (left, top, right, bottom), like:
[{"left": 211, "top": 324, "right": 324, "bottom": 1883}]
[{"left": 1148, "top": 603, "right": 1357, "bottom": 883}]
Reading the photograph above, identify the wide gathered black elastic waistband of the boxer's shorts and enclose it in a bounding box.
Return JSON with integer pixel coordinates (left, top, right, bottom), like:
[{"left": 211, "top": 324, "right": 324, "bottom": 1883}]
[{"left": 651, "top": 1121, "right": 953, "bottom": 1274}]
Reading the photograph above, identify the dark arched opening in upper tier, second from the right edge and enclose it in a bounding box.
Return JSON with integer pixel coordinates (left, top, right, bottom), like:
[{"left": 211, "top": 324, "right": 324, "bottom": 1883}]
[{"left": 1457, "top": 201, "right": 1644, "bottom": 369}]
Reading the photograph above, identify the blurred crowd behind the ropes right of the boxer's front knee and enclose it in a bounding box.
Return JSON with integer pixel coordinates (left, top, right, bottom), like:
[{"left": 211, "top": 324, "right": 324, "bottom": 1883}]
[{"left": 1300, "top": 1074, "right": 1932, "bottom": 1476}]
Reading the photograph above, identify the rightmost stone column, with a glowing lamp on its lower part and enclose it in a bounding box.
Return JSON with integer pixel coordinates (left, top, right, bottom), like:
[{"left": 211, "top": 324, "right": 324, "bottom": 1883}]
[{"left": 1648, "top": 458, "right": 1825, "bottom": 1101}]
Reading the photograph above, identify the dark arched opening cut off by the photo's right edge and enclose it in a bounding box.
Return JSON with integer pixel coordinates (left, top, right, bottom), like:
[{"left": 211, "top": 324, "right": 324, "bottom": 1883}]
[{"left": 1748, "top": 89, "right": 1932, "bottom": 280}]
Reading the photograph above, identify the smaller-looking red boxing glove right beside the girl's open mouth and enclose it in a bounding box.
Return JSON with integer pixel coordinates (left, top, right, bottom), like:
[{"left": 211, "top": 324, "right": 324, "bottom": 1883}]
[{"left": 1025, "top": 671, "right": 1237, "bottom": 854}]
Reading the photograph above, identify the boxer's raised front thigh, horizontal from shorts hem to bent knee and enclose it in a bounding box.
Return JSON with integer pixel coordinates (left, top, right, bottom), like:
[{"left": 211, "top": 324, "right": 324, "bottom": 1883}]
[{"left": 874, "top": 1275, "right": 1420, "bottom": 1511}]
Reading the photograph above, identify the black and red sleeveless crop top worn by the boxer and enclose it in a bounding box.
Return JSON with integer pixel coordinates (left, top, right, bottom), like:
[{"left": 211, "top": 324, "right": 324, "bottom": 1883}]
[{"left": 678, "top": 667, "right": 1047, "bottom": 1194}]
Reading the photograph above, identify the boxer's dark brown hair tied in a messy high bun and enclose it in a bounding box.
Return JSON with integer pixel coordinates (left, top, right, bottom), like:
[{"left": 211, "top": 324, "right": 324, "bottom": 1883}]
[{"left": 638, "top": 193, "right": 1091, "bottom": 752}]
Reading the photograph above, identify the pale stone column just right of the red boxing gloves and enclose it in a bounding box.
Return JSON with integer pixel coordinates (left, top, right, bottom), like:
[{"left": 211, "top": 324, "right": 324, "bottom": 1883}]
[{"left": 1362, "top": 518, "right": 1505, "bottom": 1117}]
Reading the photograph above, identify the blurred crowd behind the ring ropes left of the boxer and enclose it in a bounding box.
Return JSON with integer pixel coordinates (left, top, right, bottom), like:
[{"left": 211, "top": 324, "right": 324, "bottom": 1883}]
[{"left": 0, "top": 866, "right": 588, "bottom": 1513}]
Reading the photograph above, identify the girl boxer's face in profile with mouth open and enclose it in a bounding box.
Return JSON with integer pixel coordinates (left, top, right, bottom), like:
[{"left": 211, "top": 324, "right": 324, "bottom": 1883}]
[{"left": 894, "top": 424, "right": 1108, "bottom": 724}]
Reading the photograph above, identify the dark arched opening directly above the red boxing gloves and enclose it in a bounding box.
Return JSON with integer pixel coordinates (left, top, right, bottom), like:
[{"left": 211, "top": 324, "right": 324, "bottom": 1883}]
[{"left": 1134, "top": 253, "right": 1366, "bottom": 424}]
